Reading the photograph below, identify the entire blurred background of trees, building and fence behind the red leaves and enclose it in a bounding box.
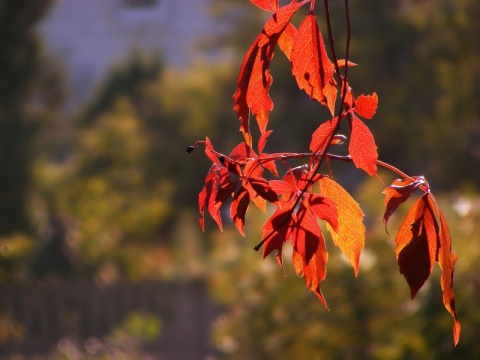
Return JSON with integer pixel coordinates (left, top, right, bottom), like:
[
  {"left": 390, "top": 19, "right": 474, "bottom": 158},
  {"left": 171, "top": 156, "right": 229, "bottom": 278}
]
[{"left": 0, "top": 0, "right": 480, "bottom": 359}]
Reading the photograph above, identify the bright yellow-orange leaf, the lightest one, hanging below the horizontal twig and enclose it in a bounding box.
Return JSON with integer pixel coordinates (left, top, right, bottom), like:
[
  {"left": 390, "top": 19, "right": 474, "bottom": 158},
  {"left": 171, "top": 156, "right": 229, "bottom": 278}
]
[{"left": 319, "top": 176, "right": 365, "bottom": 276}]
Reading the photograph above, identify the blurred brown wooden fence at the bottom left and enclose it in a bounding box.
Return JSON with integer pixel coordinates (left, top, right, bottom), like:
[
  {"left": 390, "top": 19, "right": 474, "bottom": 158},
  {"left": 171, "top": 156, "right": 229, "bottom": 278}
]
[{"left": 0, "top": 280, "right": 215, "bottom": 359}]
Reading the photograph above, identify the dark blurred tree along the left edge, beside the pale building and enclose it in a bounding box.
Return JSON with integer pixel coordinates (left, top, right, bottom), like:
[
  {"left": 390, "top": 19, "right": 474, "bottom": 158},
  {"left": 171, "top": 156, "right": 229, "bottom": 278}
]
[{"left": 0, "top": 0, "right": 51, "bottom": 235}]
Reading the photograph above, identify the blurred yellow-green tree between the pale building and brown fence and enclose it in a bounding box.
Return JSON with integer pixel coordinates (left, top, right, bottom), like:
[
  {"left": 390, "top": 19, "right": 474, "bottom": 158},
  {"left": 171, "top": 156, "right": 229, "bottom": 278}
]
[{"left": 35, "top": 54, "right": 242, "bottom": 281}]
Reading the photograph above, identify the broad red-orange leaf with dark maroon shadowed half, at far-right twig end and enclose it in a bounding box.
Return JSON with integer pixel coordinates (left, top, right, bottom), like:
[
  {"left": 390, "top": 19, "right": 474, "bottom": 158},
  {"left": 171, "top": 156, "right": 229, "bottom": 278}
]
[{"left": 395, "top": 194, "right": 439, "bottom": 299}]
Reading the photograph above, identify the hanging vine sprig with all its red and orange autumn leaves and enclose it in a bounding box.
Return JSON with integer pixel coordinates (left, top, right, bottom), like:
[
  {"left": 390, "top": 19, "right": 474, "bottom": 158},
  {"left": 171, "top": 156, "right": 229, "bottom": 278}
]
[{"left": 187, "top": 0, "right": 460, "bottom": 344}]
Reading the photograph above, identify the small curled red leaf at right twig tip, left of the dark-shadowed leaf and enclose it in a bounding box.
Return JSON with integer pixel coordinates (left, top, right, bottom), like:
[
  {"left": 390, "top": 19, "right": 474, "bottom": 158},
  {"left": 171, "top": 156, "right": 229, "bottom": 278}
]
[{"left": 382, "top": 176, "right": 425, "bottom": 232}]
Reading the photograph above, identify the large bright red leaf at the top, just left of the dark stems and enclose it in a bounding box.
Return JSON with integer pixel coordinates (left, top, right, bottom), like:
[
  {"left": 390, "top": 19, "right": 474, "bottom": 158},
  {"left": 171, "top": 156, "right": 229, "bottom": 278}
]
[{"left": 291, "top": 12, "right": 336, "bottom": 114}]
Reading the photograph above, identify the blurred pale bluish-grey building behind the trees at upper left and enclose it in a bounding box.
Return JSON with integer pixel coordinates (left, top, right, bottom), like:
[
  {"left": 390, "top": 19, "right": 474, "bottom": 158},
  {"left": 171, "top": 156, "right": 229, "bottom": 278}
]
[{"left": 40, "top": 0, "right": 215, "bottom": 103}]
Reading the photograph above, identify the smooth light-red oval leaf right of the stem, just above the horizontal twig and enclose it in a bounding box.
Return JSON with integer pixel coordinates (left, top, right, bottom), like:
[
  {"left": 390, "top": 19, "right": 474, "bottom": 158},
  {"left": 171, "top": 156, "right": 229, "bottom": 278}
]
[{"left": 348, "top": 114, "right": 378, "bottom": 176}]
